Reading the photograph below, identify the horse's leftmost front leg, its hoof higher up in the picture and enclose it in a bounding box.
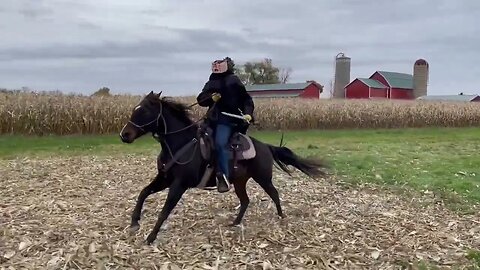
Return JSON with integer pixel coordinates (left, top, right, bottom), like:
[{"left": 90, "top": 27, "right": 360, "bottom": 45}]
[{"left": 130, "top": 173, "right": 168, "bottom": 232}]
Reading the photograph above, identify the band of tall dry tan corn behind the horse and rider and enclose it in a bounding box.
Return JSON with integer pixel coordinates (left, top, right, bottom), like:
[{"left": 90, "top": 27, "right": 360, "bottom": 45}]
[{"left": 0, "top": 93, "right": 480, "bottom": 135}]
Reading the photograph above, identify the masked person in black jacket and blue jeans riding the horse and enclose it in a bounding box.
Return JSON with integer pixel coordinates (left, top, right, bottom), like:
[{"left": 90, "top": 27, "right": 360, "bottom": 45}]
[{"left": 197, "top": 57, "right": 254, "bottom": 192}]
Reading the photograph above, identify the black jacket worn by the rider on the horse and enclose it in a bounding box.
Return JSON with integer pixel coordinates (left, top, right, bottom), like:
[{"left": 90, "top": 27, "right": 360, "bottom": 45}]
[{"left": 197, "top": 71, "right": 255, "bottom": 124}]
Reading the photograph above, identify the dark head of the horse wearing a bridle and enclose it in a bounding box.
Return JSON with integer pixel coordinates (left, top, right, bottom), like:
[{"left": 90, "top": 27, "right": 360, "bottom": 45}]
[{"left": 120, "top": 91, "right": 162, "bottom": 143}]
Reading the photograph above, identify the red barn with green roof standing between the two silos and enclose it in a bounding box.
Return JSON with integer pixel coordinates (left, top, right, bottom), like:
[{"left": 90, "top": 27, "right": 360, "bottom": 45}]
[{"left": 345, "top": 71, "right": 414, "bottom": 99}]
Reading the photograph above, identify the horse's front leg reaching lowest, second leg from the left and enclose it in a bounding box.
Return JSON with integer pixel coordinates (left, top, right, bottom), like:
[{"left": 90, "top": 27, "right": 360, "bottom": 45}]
[{"left": 147, "top": 179, "right": 187, "bottom": 244}]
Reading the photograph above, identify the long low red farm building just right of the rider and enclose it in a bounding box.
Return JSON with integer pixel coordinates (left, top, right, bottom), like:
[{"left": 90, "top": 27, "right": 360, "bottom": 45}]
[{"left": 246, "top": 81, "right": 323, "bottom": 99}]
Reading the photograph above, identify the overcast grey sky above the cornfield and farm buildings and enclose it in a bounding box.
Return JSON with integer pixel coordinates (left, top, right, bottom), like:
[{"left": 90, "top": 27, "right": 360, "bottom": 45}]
[{"left": 0, "top": 0, "right": 480, "bottom": 95}]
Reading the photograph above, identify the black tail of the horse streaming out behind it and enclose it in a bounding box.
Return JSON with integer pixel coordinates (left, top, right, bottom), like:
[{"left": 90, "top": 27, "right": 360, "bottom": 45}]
[{"left": 268, "top": 134, "right": 329, "bottom": 178}]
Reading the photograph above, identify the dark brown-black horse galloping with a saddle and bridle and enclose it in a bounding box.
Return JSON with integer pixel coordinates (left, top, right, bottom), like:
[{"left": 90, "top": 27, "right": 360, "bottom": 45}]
[{"left": 119, "top": 91, "right": 329, "bottom": 244}]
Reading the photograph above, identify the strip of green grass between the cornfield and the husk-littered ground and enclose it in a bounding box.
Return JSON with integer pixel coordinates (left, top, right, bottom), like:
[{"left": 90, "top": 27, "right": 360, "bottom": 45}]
[{"left": 0, "top": 128, "right": 480, "bottom": 210}]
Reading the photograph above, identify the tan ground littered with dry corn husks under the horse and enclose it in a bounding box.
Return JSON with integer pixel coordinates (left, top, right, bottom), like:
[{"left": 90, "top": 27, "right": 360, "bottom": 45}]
[{"left": 0, "top": 156, "right": 480, "bottom": 269}]
